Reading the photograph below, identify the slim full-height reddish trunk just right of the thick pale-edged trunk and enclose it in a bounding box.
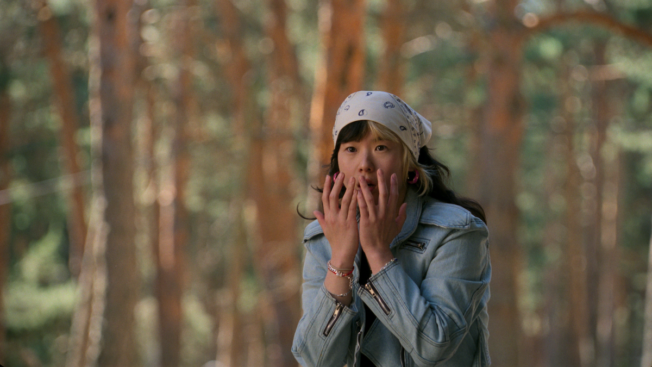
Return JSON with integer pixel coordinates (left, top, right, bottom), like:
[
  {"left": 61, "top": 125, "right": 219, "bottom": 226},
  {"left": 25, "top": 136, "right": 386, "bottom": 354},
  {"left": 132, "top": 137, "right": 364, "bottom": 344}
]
[{"left": 156, "top": 0, "right": 194, "bottom": 367}]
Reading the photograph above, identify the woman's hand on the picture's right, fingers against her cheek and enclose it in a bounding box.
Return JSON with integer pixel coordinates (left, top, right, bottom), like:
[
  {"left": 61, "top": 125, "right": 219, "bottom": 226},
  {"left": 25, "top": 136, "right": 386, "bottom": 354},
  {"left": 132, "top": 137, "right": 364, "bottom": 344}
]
[{"left": 357, "top": 169, "right": 407, "bottom": 274}]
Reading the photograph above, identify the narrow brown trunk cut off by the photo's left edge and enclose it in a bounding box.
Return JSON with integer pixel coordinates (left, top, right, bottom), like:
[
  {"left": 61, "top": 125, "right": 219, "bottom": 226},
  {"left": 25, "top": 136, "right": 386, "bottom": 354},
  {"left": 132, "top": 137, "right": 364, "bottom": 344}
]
[{"left": 0, "top": 54, "right": 11, "bottom": 363}]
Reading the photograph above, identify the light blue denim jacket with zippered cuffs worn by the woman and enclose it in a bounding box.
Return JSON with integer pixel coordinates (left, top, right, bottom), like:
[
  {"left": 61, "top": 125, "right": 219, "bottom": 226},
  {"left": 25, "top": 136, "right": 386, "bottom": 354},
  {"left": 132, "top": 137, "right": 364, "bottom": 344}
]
[{"left": 292, "top": 189, "right": 491, "bottom": 367}]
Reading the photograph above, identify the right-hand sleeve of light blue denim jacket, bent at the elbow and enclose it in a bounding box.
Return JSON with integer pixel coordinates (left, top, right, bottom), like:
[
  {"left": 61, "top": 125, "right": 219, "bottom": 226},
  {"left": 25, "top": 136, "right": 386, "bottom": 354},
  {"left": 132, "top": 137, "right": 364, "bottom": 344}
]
[{"left": 359, "top": 217, "right": 491, "bottom": 366}]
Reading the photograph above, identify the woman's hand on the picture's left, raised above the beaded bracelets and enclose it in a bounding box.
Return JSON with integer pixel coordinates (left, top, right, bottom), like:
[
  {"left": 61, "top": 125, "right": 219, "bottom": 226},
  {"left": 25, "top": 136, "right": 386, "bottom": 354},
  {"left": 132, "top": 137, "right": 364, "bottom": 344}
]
[{"left": 313, "top": 172, "right": 360, "bottom": 269}]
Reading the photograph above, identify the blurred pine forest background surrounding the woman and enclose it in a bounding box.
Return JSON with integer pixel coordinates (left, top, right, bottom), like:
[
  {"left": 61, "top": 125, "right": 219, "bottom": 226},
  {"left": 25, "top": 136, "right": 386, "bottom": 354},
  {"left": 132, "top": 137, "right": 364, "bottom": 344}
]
[{"left": 0, "top": 0, "right": 652, "bottom": 367}]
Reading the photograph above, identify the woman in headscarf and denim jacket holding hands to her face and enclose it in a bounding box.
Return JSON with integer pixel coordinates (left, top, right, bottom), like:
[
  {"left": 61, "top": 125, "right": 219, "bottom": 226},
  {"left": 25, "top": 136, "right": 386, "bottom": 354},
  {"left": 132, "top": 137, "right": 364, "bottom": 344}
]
[{"left": 292, "top": 91, "right": 491, "bottom": 367}]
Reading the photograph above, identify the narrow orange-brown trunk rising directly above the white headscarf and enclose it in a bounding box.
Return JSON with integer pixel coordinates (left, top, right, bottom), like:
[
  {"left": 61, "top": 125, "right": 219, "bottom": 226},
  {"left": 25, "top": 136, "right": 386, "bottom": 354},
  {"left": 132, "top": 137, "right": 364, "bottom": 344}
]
[{"left": 378, "top": 0, "right": 407, "bottom": 96}]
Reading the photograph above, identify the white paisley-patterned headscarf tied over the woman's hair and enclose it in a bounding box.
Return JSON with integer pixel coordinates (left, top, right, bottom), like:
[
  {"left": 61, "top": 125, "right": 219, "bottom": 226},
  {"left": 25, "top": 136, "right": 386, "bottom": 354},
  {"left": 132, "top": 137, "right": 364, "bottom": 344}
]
[{"left": 333, "top": 91, "right": 432, "bottom": 159}]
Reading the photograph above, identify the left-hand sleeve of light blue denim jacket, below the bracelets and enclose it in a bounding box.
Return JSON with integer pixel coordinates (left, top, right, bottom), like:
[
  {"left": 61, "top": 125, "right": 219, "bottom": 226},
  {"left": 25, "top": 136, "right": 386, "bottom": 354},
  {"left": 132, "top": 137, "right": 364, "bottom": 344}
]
[{"left": 292, "top": 237, "right": 357, "bottom": 367}]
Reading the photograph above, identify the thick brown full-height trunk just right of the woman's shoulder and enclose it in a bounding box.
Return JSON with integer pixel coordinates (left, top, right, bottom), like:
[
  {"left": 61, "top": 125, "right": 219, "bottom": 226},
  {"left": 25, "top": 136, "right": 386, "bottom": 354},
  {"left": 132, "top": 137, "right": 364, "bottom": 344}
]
[{"left": 475, "top": 0, "right": 525, "bottom": 366}]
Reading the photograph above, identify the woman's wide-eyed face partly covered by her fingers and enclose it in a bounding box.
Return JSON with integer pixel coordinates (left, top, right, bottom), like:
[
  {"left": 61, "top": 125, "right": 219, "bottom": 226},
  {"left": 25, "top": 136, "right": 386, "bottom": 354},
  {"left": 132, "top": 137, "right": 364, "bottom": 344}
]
[{"left": 337, "top": 133, "right": 407, "bottom": 204}]
